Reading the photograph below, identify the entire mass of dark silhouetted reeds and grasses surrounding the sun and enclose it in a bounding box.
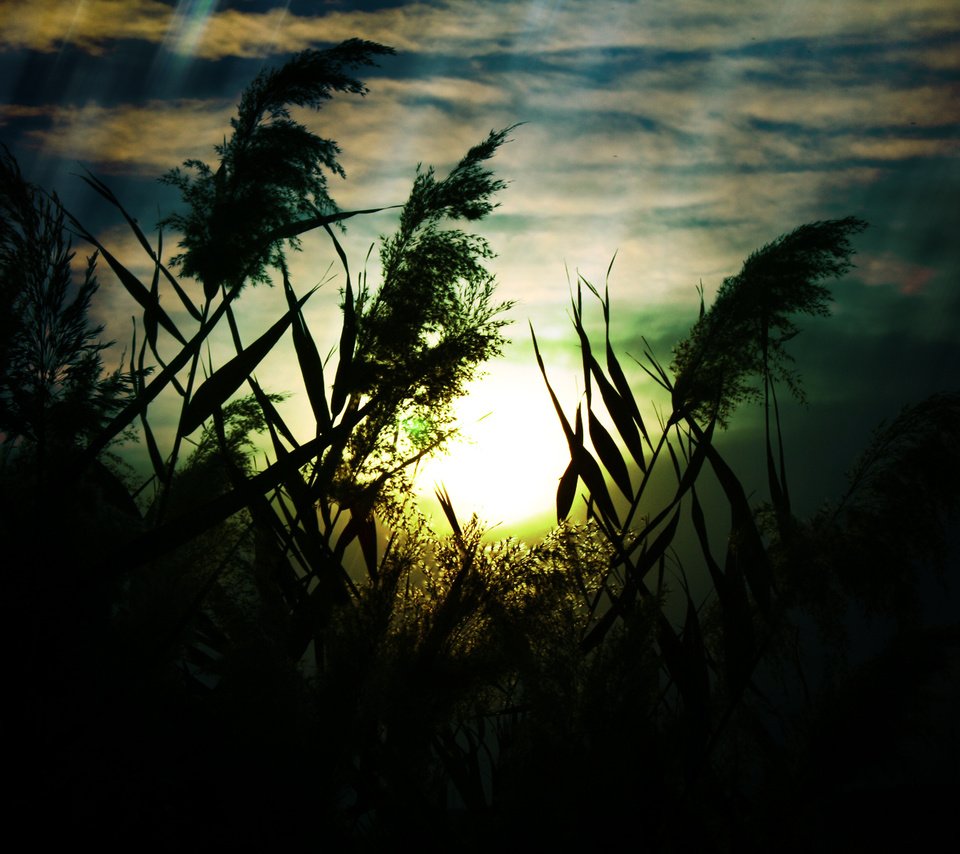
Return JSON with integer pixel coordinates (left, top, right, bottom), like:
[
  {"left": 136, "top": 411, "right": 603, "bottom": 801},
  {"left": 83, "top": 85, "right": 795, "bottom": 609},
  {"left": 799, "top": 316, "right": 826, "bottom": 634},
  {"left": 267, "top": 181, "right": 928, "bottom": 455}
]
[{"left": 0, "top": 41, "right": 960, "bottom": 852}]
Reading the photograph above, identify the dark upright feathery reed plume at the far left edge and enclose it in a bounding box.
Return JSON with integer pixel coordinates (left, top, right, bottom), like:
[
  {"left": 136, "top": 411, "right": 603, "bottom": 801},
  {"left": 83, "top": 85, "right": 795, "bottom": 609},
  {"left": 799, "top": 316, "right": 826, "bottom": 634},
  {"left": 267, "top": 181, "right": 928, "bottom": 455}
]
[{"left": 0, "top": 148, "right": 131, "bottom": 468}]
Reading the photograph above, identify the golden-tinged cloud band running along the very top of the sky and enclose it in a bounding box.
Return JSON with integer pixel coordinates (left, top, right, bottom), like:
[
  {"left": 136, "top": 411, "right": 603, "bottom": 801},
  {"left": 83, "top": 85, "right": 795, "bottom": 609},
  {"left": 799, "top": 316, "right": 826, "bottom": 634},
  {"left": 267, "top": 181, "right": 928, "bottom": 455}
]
[{"left": 0, "top": 0, "right": 958, "bottom": 62}]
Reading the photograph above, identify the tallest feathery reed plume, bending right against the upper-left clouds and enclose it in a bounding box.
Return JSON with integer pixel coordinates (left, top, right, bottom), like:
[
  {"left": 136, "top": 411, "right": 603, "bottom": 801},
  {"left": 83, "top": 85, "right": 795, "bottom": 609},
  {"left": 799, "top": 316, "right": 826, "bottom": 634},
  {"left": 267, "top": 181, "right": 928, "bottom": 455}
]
[{"left": 165, "top": 39, "right": 394, "bottom": 300}]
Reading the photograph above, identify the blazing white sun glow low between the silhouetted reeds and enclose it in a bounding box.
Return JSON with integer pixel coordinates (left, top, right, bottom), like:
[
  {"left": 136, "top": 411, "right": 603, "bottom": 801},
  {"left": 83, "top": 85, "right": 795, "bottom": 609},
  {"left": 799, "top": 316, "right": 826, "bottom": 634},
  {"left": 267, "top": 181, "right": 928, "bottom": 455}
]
[{"left": 416, "top": 363, "right": 569, "bottom": 536}]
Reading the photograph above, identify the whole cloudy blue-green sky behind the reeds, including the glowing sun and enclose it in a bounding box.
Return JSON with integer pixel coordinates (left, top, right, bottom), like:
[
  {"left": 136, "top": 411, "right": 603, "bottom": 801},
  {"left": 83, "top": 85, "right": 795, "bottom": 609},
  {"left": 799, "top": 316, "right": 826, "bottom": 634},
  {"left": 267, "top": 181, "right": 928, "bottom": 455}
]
[{"left": 0, "top": 0, "right": 960, "bottom": 535}]
